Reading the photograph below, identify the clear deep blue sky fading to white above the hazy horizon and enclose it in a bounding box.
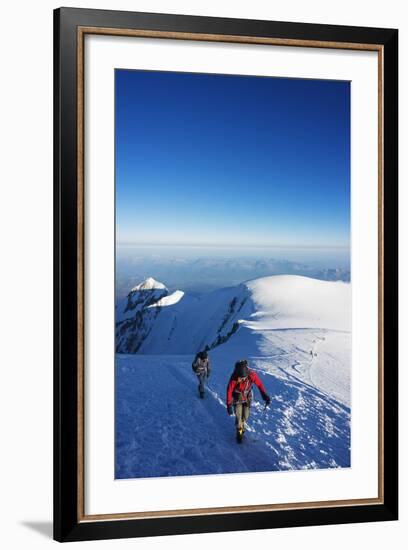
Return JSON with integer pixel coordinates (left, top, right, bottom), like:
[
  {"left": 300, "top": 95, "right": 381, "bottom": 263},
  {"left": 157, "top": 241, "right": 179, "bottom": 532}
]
[{"left": 115, "top": 69, "right": 350, "bottom": 248}]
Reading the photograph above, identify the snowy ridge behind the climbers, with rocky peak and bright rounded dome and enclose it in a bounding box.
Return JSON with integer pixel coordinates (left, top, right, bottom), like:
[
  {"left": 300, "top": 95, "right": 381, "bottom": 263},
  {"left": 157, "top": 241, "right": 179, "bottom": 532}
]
[{"left": 116, "top": 275, "right": 351, "bottom": 355}]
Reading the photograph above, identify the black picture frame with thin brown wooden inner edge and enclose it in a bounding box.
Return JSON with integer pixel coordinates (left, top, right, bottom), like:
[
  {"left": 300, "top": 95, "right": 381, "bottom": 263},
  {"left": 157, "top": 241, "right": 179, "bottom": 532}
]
[{"left": 54, "top": 8, "right": 398, "bottom": 541}]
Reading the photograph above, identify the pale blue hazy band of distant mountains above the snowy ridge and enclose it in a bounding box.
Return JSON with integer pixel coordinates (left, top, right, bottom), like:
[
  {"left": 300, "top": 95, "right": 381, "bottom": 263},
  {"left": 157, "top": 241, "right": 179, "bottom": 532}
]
[{"left": 116, "top": 245, "right": 350, "bottom": 299}]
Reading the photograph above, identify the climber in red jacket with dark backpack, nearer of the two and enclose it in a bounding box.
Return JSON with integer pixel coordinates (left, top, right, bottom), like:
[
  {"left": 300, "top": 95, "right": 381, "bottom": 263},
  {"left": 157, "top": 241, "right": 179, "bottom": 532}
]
[{"left": 227, "top": 359, "right": 271, "bottom": 443}]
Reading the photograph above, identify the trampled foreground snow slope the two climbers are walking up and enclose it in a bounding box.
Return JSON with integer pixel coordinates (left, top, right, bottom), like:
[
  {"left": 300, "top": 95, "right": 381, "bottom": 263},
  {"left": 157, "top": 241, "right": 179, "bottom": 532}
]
[{"left": 115, "top": 329, "right": 350, "bottom": 478}]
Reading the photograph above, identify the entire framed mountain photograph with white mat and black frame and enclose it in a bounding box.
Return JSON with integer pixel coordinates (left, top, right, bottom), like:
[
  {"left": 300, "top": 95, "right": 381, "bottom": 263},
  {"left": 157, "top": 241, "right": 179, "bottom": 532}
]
[{"left": 54, "top": 8, "right": 398, "bottom": 541}]
